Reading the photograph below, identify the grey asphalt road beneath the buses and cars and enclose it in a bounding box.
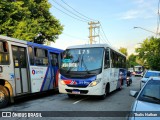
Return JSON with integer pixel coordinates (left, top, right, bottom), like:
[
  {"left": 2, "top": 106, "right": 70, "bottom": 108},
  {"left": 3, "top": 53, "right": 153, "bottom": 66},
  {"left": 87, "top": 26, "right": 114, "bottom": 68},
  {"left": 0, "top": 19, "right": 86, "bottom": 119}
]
[{"left": 0, "top": 77, "right": 140, "bottom": 120}]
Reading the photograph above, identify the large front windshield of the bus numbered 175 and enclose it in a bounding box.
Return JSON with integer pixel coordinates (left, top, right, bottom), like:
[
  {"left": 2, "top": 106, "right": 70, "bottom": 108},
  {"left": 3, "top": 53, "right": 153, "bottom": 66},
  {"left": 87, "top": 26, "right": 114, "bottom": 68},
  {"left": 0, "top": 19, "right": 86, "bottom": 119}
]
[{"left": 61, "top": 48, "right": 104, "bottom": 72}]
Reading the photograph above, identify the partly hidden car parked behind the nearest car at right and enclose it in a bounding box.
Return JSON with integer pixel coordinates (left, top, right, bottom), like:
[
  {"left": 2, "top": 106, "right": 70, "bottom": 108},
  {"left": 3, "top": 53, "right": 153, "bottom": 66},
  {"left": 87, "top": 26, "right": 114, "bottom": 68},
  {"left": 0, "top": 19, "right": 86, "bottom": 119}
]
[{"left": 140, "top": 70, "right": 160, "bottom": 89}]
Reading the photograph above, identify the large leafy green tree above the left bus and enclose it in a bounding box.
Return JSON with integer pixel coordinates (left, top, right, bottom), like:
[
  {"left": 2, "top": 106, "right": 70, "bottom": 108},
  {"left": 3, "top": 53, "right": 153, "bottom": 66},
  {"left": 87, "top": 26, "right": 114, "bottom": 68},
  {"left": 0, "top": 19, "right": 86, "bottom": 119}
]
[{"left": 0, "top": 0, "right": 63, "bottom": 43}]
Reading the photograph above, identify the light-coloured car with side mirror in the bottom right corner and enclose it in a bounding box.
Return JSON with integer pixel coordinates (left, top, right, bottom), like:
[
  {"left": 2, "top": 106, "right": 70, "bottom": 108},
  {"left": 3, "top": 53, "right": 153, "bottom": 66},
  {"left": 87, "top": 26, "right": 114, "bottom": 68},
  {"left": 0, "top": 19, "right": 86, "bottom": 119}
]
[{"left": 128, "top": 77, "right": 160, "bottom": 120}]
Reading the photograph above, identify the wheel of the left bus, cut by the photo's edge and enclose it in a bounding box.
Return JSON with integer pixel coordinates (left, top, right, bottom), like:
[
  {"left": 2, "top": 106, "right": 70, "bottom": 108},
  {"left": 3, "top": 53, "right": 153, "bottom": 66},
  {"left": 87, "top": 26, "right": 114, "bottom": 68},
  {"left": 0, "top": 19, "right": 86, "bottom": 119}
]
[{"left": 0, "top": 85, "right": 9, "bottom": 108}]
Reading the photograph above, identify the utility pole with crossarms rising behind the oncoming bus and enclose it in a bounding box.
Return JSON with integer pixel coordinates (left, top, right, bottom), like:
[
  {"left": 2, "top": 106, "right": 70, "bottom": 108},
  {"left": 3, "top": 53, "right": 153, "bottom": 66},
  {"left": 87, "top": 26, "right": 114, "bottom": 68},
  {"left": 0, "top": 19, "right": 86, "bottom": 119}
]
[{"left": 88, "top": 21, "right": 100, "bottom": 44}]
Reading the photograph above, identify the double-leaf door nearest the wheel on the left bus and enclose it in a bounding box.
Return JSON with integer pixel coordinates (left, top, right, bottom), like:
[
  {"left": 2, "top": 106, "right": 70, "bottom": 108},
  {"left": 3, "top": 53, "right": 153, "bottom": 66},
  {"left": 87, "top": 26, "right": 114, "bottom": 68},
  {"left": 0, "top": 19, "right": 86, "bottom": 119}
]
[{"left": 12, "top": 46, "right": 29, "bottom": 95}]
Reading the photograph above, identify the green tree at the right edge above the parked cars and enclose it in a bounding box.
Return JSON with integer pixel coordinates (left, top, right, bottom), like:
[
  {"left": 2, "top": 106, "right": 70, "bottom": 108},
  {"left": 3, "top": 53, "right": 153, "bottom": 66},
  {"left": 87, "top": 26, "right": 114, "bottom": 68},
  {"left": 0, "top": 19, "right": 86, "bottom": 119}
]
[{"left": 136, "top": 37, "right": 160, "bottom": 70}]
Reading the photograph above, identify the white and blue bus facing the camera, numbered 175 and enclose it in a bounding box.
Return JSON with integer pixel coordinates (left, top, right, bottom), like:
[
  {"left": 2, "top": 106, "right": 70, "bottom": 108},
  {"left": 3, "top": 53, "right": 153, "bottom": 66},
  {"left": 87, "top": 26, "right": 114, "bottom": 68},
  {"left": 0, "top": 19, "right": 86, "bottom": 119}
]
[{"left": 58, "top": 44, "right": 126, "bottom": 99}]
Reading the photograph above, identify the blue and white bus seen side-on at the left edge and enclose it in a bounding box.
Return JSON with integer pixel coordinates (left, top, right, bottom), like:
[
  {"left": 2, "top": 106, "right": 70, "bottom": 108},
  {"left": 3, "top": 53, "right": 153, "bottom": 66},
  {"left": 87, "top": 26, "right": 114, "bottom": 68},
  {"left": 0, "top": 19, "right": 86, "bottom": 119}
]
[{"left": 0, "top": 35, "right": 63, "bottom": 107}]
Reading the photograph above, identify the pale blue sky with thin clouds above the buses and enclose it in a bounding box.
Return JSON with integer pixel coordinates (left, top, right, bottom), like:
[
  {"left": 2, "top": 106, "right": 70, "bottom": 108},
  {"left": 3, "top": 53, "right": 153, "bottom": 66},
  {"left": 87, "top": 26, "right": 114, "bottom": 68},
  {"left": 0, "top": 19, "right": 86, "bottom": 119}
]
[{"left": 49, "top": 0, "right": 159, "bottom": 54}]
